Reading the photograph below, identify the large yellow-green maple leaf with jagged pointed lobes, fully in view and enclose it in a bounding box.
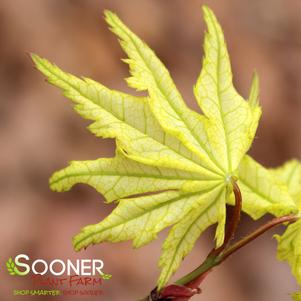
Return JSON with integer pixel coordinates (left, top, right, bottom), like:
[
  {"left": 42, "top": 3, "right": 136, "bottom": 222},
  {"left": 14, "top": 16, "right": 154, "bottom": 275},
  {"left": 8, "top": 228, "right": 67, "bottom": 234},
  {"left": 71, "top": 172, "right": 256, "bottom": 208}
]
[{"left": 32, "top": 7, "right": 295, "bottom": 289}]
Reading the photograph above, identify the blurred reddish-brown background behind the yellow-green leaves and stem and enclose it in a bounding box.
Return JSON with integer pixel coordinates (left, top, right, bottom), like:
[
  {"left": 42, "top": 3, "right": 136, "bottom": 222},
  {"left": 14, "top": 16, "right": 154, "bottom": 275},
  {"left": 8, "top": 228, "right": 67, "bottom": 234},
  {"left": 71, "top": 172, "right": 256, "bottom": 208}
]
[{"left": 0, "top": 0, "right": 301, "bottom": 301}]
